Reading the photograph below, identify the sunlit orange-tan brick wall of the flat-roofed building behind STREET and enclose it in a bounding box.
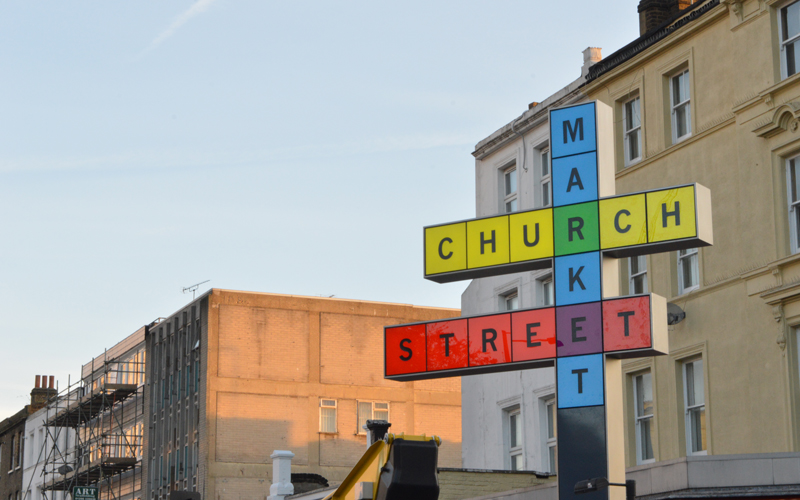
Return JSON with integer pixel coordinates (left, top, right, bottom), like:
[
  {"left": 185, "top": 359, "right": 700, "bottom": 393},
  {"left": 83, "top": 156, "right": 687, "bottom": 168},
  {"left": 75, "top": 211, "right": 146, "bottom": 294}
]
[{"left": 202, "top": 290, "right": 461, "bottom": 500}]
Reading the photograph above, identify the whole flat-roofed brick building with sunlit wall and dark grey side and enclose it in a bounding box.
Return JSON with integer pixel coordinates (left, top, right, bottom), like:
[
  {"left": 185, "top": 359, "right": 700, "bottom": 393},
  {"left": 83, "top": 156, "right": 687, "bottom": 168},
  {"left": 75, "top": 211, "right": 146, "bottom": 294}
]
[{"left": 144, "top": 289, "right": 461, "bottom": 500}]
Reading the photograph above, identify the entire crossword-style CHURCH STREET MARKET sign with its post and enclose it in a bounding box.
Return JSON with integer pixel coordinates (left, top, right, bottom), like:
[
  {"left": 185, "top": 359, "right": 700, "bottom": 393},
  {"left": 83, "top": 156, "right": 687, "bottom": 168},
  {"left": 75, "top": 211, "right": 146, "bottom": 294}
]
[{"left": 384, "top": 102, "right": 713, "bottom": 500}]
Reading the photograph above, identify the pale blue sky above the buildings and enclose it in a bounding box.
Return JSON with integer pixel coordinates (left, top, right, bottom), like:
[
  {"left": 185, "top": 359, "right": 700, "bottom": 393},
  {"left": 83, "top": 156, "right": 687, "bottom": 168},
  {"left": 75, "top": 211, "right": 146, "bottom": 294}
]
[{"left": 0, "top": 0, "right": 638, "bottom": 418}]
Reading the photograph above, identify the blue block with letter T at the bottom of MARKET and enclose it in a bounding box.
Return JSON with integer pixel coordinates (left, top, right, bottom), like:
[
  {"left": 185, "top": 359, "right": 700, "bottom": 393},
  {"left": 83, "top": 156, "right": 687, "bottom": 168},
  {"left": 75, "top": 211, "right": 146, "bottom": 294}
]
[{"left": 556, "top": 354, "right": 605, "bottom": 408}]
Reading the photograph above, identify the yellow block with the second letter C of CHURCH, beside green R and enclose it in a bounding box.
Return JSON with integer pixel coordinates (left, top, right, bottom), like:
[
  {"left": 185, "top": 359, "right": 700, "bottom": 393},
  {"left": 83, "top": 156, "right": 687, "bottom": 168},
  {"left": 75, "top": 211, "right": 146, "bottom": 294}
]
[{"left": 600, "top": 193, "right": 647, "bottom": 250}]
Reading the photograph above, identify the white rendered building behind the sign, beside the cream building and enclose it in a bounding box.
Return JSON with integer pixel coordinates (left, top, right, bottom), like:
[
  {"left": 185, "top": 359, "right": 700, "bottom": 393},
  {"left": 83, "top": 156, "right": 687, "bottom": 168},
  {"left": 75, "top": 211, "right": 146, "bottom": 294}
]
[{"left": 461, "top": 53, "right": 600, "bottom": 472}]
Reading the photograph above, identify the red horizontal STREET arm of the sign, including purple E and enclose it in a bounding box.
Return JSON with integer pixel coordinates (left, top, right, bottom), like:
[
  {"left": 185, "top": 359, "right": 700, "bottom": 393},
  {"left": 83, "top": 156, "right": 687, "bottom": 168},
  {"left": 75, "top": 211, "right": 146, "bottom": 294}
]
[{"left": 384, "top": 294, "right": 668, "bottom": 378}]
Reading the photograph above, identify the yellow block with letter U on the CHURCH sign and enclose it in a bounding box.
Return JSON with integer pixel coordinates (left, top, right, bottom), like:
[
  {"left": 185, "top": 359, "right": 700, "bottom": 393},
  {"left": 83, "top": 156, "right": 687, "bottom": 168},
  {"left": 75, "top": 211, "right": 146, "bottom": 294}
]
[{"left": 508, "top": 208, "right": 553, "bottom": 262}]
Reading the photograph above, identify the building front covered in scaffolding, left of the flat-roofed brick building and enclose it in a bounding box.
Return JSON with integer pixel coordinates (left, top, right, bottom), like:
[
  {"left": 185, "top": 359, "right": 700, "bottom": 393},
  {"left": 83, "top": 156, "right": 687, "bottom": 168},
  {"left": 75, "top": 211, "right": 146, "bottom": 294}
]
[{"left": 39, "top": 350, "right": 145, "bottom": 500}]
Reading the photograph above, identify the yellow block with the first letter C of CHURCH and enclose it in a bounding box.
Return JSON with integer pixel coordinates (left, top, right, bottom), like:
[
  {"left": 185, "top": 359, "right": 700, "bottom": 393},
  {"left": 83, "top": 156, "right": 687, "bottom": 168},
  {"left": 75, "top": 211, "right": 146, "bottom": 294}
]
[{"left": 425, "top": 222, "right": 467, "bottom": 276}]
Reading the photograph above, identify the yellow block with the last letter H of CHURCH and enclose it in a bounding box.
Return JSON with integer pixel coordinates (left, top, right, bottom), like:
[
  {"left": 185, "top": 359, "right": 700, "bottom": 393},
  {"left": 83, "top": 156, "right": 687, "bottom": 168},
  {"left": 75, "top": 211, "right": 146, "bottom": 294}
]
[{"left": 647, "top": 186, "right": 697, "bottom": 243}]
